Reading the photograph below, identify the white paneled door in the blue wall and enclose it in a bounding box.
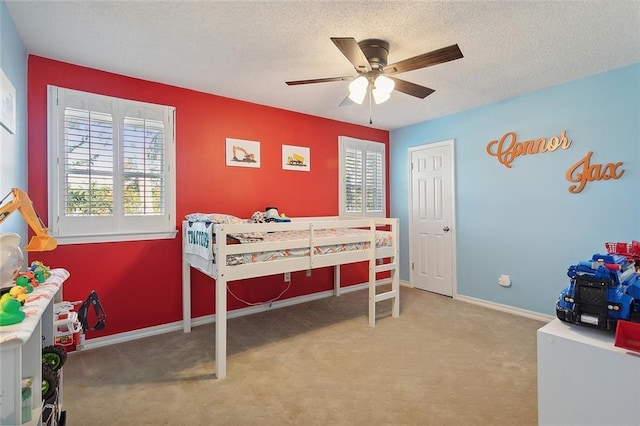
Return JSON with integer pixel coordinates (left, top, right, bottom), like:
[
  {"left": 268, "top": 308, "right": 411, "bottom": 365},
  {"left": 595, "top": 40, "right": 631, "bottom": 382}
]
[{"left": 409, "top": 140, "right": 455, "bottom": 296}]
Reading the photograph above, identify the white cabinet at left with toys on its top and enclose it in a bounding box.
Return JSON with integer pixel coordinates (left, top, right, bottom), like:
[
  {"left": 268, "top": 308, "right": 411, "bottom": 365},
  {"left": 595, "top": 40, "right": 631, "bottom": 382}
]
[{"left": 0, "top": 269, "right": 69, "bottom": 425}]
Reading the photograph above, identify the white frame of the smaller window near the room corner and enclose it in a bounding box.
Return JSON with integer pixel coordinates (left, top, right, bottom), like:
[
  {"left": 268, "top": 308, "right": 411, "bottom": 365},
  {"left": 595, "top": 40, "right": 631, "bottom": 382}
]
[{"left": 338, "top": 136, "right": 387, "bottom": 217}]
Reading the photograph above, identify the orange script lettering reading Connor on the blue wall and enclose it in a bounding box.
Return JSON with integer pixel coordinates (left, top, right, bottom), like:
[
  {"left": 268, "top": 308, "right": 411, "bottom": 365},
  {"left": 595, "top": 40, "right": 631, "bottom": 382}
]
[{"left": 487, "top": 130, "right": 571, "bottom": 169}]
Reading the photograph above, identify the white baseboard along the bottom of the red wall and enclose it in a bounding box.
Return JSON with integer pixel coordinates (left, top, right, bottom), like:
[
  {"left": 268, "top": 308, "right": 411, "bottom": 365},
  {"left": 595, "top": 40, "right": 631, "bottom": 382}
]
[{"left": 76, "top": 279, "right": 382, "bottom": 351}]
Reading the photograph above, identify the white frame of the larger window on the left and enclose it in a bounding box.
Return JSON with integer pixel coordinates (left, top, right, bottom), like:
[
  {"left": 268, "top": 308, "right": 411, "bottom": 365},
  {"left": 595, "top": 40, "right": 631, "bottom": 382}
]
[{"left": 47, "top": 86, "right": 177, "bottom": 245}]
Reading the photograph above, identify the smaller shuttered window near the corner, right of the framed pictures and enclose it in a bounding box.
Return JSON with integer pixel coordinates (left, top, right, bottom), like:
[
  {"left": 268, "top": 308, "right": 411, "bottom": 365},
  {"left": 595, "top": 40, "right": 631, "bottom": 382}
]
[{"left": 338, "top": 136, "right": 387, "bottom": 217}]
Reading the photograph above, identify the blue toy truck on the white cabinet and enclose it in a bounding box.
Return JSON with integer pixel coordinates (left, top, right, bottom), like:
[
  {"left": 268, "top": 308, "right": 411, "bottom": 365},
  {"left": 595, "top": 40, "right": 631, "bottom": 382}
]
[{"left": 556, "top": 254, "right": 640, "bottom": 330}]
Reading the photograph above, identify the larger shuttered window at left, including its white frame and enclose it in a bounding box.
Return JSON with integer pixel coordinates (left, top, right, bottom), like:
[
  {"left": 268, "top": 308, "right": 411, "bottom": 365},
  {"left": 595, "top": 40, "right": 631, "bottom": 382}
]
[{"left": 48, "top": 86, "right": 176, "bottom": 244}]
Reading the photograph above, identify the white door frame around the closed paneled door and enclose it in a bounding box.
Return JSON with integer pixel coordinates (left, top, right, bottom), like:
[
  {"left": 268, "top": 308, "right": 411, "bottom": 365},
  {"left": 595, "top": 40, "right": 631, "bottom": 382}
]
[{"left": 407, "top": 139, "right": 458, "bottom": 298}]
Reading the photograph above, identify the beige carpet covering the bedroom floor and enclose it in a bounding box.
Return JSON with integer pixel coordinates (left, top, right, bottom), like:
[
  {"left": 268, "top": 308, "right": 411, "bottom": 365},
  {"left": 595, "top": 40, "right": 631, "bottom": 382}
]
[{"left": 64, "top": 287, "right": 544, "bottom": 426}]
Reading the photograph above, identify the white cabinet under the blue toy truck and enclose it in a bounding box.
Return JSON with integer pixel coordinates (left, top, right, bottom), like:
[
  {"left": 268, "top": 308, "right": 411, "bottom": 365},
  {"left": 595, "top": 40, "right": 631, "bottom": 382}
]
[{"left": 538, "top": 319, "right": 640, "bottom": 426}]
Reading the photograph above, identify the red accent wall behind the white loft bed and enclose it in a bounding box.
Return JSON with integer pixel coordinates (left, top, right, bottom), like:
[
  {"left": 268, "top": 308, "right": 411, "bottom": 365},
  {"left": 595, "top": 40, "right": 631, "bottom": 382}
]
[{"left": 27, "top": 55, "right": 389, "bottom": 338}]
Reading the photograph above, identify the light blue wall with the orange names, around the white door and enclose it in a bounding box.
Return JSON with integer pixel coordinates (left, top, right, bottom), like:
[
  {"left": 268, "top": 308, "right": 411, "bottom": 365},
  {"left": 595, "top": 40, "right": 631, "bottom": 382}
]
[{"left": 390, "top": 64, "right": 640, "bottom": 315}]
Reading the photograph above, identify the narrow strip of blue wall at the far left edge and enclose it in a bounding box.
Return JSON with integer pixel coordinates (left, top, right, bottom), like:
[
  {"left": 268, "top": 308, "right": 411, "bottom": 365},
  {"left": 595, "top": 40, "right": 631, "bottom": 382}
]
[{"left": 0, "top": 1, "right": 27, "bottom": 240}]
